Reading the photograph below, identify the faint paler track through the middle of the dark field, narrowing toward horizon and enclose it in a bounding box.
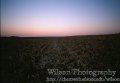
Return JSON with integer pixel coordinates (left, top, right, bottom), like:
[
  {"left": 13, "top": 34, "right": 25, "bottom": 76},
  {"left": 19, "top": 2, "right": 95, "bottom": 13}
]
[{"left": 40, "top": 39, "right": 61, "bottom": 68}]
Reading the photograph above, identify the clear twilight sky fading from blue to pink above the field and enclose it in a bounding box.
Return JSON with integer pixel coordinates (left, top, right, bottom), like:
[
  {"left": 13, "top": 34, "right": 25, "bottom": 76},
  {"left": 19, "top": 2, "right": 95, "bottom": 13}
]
[{"left": 1, "top": 0, "right": 120, "bottom": 37}]
